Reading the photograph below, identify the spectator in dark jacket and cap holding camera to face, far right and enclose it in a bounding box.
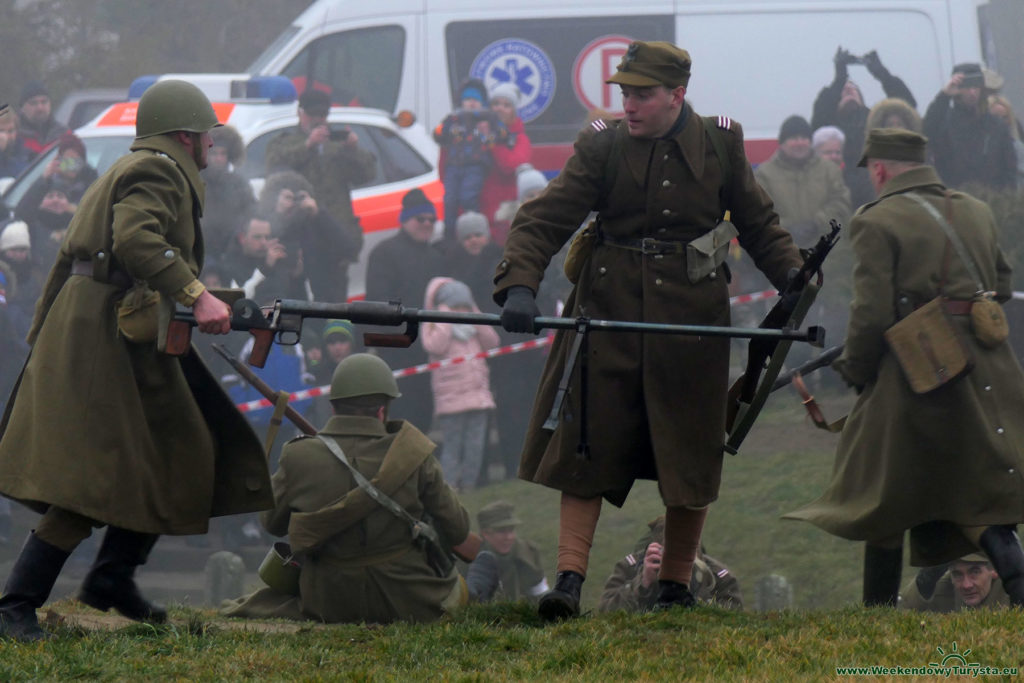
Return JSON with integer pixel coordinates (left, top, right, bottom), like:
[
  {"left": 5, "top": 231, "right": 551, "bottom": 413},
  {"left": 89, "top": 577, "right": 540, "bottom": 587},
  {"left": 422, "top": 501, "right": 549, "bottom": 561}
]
[{"left": 925, "top": 63, "right": 1017, "bottom": 189}]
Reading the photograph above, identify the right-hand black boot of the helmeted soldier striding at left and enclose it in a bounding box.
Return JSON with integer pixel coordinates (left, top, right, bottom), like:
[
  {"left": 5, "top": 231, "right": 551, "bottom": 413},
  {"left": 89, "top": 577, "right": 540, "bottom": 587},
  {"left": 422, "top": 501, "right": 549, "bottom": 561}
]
[{"left": 78, "top": 526, "right": 167, "bottom": 624}]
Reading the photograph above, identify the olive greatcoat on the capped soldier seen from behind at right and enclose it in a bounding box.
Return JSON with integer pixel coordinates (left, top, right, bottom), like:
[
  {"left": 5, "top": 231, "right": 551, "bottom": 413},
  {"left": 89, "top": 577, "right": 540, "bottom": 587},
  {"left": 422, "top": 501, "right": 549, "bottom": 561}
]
[{"left": 785, "top": 166, "right": 1024, "bottom": 565}]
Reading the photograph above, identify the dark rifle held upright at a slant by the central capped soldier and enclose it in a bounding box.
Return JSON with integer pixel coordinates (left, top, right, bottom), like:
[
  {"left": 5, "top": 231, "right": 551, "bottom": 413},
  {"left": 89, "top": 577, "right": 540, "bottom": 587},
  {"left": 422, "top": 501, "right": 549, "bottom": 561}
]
[{"left": 725, "top": 220, "right": 842, "bottom": 455}]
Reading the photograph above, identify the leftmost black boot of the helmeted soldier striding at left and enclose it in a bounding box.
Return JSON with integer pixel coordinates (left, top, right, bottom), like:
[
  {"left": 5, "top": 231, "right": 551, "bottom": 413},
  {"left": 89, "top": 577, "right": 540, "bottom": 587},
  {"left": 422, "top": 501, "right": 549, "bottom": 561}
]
[{"left": 0, "top": 533, "right": 71, "bottom": 642}]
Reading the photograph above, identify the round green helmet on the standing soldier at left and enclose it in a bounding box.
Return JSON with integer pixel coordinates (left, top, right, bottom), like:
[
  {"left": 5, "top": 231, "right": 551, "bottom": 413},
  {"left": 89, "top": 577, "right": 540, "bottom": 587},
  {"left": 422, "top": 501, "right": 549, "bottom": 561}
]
[{"left": 135, "top": 80, "right": 220, "bottom": 137}]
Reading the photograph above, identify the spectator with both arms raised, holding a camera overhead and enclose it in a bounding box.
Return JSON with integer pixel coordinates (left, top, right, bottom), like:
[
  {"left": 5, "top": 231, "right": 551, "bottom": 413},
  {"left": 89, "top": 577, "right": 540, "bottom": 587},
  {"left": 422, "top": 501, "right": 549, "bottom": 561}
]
[{"left": 811, "top": 46, "right": 918, "bottom": 208}]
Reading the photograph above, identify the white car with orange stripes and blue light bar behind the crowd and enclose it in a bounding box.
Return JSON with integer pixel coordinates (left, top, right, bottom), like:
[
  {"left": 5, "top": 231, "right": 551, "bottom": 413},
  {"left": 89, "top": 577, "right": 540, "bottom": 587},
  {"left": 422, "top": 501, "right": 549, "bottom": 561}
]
[{"left": 2, "top": 77, "right": 444, "bottom": 298}]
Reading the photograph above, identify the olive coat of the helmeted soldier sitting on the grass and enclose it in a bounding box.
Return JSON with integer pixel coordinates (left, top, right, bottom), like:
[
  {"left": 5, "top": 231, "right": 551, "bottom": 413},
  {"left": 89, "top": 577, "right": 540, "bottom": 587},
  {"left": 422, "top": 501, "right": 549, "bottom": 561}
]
[{"left": 222, "top": 416, "right": 469, "bottom": 624}]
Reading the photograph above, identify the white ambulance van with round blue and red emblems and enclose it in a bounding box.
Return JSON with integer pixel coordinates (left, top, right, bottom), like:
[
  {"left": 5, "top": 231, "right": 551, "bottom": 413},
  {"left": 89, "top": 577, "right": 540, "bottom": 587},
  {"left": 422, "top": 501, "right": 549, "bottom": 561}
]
[{"left": 241, "top": 0, "right": 1024, "bottom": 170}]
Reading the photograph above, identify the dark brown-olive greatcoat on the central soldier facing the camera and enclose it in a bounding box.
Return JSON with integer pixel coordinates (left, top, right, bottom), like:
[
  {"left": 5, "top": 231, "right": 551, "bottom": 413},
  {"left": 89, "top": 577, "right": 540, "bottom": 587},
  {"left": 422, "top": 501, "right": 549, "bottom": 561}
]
[{"left": 495, "top": 105, "right": 802, "bottom": 506}]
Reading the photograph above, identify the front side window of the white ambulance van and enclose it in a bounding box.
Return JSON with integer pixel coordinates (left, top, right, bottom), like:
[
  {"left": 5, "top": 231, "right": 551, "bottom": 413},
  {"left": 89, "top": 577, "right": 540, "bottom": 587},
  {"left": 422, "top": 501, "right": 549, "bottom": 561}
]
[{"left": 283, "top": 26, "right": 406, "bottom": 112}]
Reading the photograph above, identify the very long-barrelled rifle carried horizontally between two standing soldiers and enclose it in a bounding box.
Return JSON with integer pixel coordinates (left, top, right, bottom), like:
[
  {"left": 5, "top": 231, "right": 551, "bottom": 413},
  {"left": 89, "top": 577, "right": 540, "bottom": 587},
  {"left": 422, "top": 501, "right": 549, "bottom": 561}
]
[{"left": 172, "top": 299, "right": 825, "bottom": 368}]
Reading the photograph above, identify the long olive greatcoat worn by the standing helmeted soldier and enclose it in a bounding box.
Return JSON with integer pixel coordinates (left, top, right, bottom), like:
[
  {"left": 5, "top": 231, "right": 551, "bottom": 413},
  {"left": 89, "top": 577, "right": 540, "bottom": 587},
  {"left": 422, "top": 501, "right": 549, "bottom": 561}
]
[{"left": 0, "top": 136, "right": 273, "bottom": 533}]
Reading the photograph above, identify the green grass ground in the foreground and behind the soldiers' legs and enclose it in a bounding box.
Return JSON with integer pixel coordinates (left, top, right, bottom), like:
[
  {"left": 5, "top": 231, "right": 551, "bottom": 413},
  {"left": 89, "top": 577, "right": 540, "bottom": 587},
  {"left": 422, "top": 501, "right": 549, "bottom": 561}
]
[{"left": 0, "top": 394, "right": 1024, "bottom": 681}]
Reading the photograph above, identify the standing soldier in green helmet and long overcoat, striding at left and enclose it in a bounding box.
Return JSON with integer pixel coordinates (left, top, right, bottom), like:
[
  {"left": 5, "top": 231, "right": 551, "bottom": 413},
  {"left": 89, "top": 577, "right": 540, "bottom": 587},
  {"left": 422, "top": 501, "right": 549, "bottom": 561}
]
[{"left": 0, "top": 81, "right": 273, "bottom": 640}]
